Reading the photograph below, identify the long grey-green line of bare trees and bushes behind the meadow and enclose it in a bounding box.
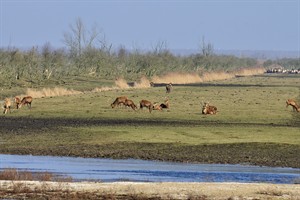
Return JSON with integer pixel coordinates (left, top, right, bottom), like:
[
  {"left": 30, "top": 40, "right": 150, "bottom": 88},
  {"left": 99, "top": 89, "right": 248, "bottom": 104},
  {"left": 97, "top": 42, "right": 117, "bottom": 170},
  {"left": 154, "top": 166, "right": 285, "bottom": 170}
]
[{"left": 0, "top": 44, "right": 300, "bottom": 87}]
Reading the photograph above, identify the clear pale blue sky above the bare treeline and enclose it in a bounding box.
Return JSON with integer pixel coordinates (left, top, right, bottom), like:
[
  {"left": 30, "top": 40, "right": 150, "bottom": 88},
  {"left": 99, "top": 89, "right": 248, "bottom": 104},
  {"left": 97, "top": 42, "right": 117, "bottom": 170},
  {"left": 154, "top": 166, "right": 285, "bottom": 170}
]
[{"left": 0, "top": 0, "right": 300, "bottom": 52}]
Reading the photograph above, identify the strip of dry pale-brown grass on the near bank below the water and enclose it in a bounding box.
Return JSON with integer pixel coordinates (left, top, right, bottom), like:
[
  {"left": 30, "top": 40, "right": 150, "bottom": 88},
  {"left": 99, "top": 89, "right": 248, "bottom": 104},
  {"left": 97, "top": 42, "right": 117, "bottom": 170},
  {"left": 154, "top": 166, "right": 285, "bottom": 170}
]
[{"left": 0, "top": 181, "right": 300, "bottom": 200}]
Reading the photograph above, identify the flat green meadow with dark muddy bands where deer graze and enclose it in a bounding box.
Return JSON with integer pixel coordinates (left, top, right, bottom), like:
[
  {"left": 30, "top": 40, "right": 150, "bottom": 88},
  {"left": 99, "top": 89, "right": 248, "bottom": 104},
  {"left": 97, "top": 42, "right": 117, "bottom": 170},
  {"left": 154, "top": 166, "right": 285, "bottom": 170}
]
[{"left": 0, "top": 75, "right": 300, "bottom": 168}]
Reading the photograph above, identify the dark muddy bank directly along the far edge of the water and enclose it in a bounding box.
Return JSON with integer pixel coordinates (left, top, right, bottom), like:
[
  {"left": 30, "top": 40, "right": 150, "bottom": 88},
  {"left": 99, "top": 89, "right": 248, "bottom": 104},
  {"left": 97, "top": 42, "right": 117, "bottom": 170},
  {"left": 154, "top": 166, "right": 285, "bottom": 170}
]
[{"left": 0, "top": 143, "right": 300, "bottom": 168}]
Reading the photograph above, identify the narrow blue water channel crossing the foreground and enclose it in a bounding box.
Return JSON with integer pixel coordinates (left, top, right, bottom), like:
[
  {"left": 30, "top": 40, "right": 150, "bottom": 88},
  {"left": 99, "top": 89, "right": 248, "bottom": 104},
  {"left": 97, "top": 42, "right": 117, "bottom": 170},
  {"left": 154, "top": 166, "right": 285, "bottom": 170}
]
[{"left": 0, "top": 154, "right": 300, "bottom": 184}]
